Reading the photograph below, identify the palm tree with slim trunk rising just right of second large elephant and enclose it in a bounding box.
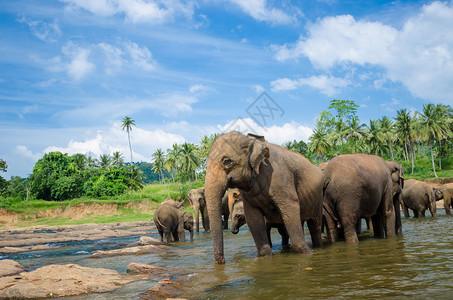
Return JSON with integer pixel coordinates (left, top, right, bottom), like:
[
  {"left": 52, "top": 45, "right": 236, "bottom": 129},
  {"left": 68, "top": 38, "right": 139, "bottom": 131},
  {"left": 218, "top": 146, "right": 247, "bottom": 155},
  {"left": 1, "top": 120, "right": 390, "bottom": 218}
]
[{"left": 395, "top": 109, "right": 415, "bottom": 174}]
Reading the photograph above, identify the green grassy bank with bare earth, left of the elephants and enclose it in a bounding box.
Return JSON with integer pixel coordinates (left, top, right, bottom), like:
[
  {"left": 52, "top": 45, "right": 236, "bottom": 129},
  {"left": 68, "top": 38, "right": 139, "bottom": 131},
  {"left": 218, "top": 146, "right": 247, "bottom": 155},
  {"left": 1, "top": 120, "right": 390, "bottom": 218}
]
[{"left": 0, "top": 181, "right": 204, "bottom": 227}]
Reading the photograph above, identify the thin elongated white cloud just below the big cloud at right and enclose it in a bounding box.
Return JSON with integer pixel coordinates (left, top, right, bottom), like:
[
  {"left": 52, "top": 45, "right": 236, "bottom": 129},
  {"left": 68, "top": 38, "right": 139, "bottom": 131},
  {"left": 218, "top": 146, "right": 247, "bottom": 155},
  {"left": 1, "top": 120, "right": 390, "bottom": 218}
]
[{"left": 271, "top": 75, "right": 350, "bottom": 96}]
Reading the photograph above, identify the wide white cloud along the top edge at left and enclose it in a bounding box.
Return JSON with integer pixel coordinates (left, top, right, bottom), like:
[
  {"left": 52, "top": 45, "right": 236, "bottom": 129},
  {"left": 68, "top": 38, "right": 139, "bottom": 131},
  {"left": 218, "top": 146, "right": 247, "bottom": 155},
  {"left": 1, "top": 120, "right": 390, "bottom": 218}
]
[{"left": 61, "top": 0, "right": 194, "bottom": 24}]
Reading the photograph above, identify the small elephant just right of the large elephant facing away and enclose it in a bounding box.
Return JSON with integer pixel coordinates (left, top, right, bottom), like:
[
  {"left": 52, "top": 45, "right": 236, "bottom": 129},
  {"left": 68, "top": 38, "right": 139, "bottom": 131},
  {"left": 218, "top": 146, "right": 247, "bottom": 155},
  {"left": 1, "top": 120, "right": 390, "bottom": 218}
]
[{"left": 401, "top": 179, "right": 441, "bottom": 218}]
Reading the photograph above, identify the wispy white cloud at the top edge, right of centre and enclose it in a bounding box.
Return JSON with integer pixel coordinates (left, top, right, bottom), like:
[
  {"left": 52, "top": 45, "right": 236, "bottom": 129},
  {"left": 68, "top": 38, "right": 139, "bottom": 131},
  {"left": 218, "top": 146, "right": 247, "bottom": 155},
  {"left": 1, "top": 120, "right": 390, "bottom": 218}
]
[{"left": 229, "top": 0, "right": 295, "bottom": 24}]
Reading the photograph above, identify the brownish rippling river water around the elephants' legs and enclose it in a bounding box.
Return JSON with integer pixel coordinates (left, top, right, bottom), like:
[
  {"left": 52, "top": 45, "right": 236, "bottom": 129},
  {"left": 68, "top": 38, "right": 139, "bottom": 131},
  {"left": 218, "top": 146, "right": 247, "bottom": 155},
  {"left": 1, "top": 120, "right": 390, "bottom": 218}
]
[{"left": 2, "top": 209, "right": 453, "bottom": 299}]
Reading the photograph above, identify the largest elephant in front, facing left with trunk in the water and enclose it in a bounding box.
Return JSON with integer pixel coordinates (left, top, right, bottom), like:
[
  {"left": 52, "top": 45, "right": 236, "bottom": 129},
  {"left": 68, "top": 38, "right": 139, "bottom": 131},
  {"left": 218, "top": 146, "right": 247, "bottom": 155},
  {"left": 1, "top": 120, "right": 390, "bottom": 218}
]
[{"left": 205, "top": 132, "right": 322, "bottom": 264}]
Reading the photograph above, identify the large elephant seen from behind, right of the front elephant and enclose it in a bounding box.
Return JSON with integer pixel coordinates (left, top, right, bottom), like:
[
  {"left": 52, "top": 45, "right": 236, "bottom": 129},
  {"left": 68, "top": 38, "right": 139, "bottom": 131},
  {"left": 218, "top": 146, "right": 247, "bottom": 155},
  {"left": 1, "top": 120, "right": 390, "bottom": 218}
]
[{"left": 323, "top": 154, "right": 404, "bottom": 244}]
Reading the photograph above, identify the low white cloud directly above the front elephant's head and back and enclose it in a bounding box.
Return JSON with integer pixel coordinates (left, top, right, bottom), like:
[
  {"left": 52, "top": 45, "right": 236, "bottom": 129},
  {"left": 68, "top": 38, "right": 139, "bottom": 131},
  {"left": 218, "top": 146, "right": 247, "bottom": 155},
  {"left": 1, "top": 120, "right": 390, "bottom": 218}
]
[{"left": 217, "top": 118, "right": 313, "bottom": 145}]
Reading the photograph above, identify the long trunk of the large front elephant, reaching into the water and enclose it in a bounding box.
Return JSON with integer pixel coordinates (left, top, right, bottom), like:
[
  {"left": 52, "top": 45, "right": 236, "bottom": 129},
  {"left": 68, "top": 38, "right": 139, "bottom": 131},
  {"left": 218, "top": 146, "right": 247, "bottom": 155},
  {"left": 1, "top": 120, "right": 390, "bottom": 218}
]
[{"left": 205, "top": 164, "right": 227, "bottom": 264}]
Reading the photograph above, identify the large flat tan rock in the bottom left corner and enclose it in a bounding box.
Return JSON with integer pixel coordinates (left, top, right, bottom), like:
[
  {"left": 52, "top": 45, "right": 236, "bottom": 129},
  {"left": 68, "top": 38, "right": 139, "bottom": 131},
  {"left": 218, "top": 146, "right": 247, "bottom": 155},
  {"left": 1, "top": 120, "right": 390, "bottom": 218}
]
[{"left": 0, "top": 264, "right": 135, "bottom": 299}]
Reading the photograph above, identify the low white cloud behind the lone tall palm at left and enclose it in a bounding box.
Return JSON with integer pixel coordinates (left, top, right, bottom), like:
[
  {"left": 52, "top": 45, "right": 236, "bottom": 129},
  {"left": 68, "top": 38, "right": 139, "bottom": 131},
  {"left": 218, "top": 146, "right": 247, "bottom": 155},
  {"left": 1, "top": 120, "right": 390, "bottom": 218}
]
[{"left": 43, "top": 123, "right": 185, "bottom": 161}]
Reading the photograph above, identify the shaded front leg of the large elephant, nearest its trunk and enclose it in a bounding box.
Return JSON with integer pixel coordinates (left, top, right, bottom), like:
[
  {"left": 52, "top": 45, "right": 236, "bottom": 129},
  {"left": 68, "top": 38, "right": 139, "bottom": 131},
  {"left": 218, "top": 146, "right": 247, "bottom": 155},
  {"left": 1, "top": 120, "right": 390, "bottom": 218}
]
[{"left": 244, "top": 201, "right": 272, "bottom": 256}]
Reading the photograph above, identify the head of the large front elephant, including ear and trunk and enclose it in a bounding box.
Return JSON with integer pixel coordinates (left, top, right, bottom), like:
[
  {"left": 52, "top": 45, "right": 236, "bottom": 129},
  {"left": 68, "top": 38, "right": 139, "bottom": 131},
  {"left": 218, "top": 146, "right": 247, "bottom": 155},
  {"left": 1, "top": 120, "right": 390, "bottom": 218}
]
[{"left": 205, "top": 132, "right": 269, "bottom": 264}]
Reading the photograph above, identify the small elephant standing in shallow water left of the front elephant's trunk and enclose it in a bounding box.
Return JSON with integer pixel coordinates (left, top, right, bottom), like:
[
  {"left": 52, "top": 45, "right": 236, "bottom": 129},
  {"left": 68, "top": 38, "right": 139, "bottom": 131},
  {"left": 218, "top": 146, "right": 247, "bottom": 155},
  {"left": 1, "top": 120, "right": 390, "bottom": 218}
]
[{"left": 154, "top": 203, "right": 193, "bottom": 243}]
